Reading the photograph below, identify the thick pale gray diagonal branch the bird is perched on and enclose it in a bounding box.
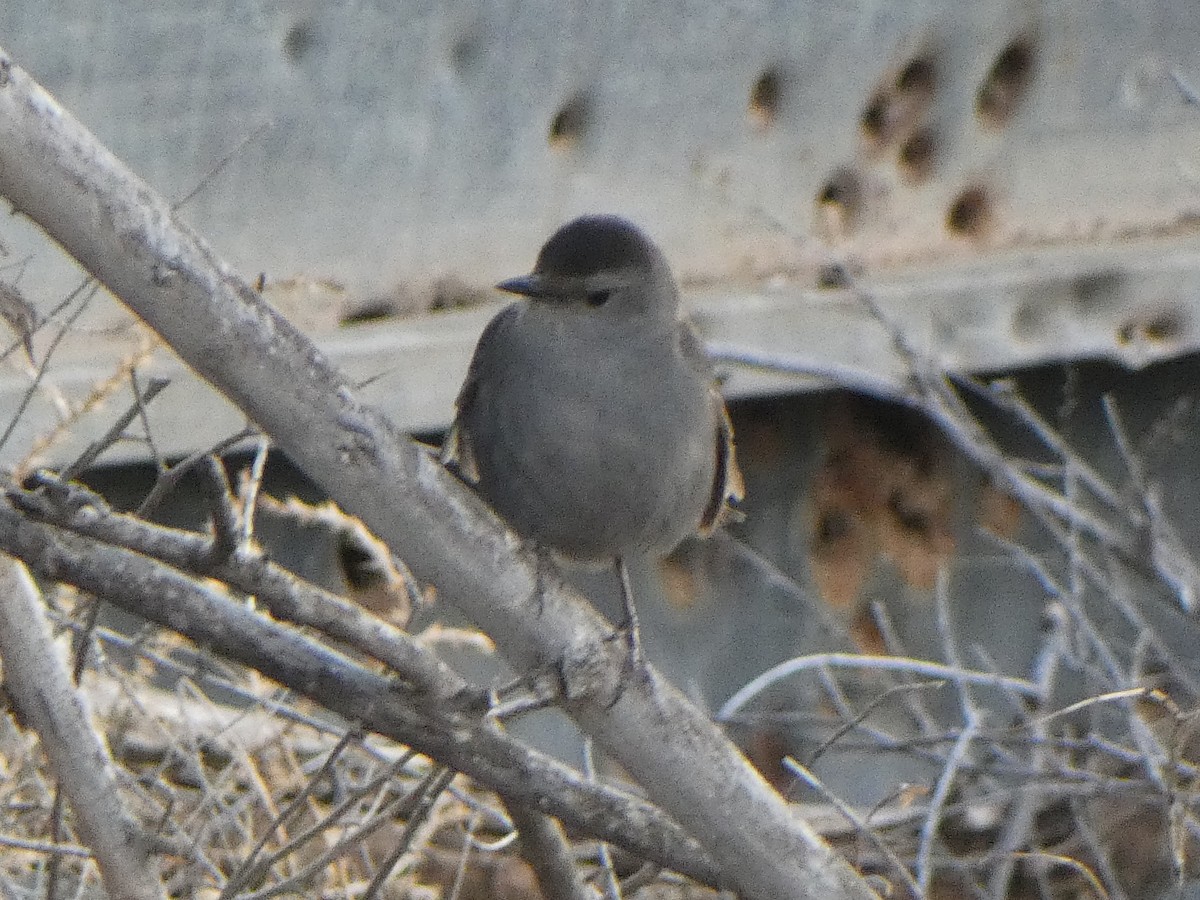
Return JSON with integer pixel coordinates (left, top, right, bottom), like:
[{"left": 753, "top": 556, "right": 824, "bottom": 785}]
[{"left": 0, "top": 38, "right": 872, "bottom": 900}]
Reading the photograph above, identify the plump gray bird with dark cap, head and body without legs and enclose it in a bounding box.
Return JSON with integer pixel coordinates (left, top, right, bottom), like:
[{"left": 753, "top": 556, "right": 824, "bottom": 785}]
[{"left": 443, "top": 216, "right": 742, "bottom": 560}]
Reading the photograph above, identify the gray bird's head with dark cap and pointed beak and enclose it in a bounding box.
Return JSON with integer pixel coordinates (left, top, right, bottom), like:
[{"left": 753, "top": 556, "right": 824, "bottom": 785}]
[{"left": 496, "top": 216, "right": 676, "bottom": 311}]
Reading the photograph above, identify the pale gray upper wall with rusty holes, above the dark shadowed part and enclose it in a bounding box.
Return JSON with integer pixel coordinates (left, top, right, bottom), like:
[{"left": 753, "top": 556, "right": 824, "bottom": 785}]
[{"left": 0, "top": 0, "right": 1200, "bottom": 464}]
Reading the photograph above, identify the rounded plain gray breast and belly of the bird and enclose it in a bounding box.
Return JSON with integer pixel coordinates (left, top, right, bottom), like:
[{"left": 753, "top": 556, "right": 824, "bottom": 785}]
[{"left": 465, "top": 314, "right": 716, "bottom": 558}]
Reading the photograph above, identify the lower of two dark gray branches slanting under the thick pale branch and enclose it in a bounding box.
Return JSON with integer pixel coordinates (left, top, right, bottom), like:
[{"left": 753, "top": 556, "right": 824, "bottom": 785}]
[{"left": 0, "top": 503, "right": 725, "bottom": 884}]
